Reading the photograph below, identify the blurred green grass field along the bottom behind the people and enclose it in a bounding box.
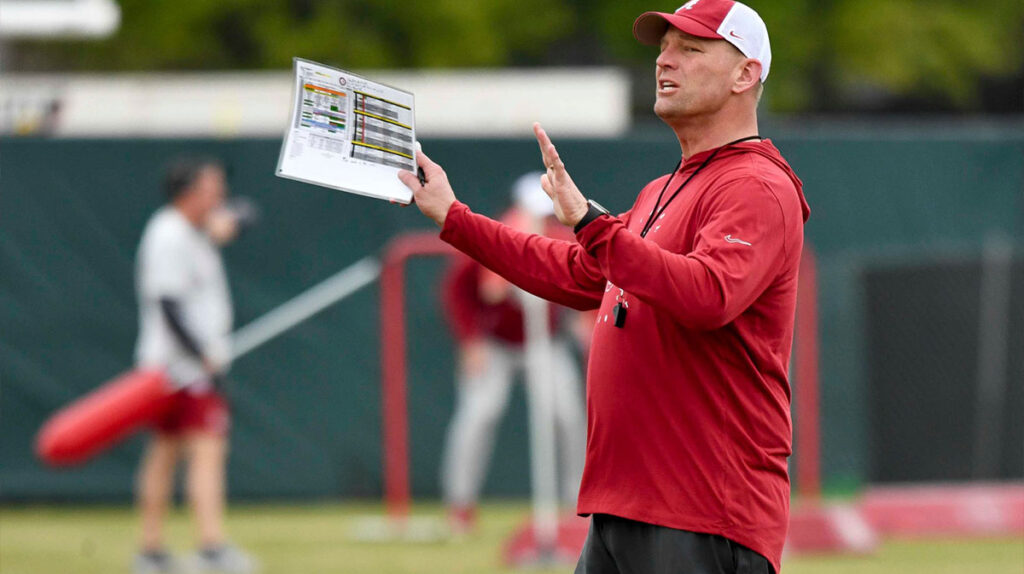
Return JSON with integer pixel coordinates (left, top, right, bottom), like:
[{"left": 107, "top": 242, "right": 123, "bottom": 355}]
[{"left": 0, "top": 502, "right": 1024, "bottom": 574}]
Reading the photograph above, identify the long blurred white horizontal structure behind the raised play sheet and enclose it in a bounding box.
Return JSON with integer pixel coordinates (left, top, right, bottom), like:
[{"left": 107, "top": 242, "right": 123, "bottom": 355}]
[{"left": 0, "top": 68, "right": 631, "bottom": 138}]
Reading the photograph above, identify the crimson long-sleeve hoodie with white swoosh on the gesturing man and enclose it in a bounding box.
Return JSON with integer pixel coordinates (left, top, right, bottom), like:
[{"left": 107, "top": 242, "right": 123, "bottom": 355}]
[{"left": 441, "top": 140, "right": 810, "bottom": 572}]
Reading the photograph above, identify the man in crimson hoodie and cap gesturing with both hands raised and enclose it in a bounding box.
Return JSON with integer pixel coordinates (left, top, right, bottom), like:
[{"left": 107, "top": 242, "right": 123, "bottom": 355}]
[{"left": 399, "top": 0, "right": 810, "bottom": 574}]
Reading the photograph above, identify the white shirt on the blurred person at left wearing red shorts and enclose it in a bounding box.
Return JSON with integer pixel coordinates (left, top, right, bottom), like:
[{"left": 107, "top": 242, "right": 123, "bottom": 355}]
[{"left": 135, "top": 206, "right": 232, "bottom": 385}]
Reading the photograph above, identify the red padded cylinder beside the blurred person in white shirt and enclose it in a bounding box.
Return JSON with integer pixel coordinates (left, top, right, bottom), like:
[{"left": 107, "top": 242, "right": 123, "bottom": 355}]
[{"left": 36, "top": 370, "right": 175, "bottom": 467}]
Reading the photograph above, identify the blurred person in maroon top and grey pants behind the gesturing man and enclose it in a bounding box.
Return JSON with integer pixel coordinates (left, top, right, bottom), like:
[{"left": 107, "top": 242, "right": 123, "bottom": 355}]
[{"left": 441, "top": 172, "right": 593, "bottom": 535}]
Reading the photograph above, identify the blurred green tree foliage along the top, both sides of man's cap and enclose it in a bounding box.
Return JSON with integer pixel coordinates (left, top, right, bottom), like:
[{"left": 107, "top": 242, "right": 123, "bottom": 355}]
[{"left": 18, "top": 0, "right": 1024, "bottom": 111}]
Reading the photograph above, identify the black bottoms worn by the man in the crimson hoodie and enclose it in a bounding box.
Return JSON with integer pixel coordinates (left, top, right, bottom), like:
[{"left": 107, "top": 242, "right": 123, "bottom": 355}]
[{"left": 575, "top": 515, "right": 774, "bottom": 574}]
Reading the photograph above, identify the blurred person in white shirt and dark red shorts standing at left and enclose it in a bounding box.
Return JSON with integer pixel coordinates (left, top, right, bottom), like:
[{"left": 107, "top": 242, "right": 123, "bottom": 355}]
[{"left": 134, "top": 159, "right": 256, "bottom": 574}]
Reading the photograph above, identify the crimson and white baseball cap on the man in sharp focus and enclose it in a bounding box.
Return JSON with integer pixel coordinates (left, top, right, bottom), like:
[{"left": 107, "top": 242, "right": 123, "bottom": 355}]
[{"left": 633, "top": 0, "right": 771, "bottom": 83}]
